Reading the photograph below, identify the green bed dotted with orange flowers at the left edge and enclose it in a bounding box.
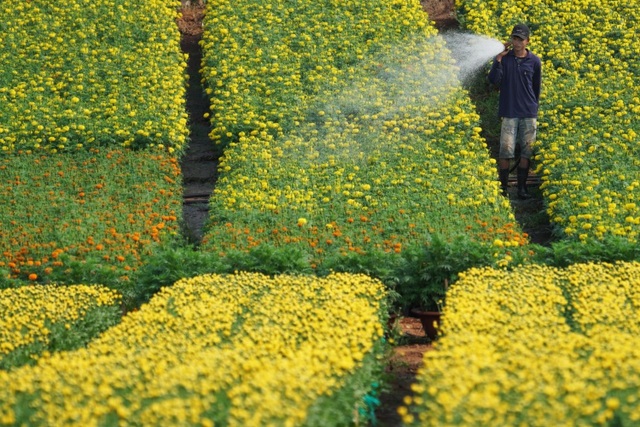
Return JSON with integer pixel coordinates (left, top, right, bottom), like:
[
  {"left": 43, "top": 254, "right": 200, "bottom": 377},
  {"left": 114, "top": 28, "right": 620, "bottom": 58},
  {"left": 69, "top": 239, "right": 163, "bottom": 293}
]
[{"left": 0, "top": 149, "right": 182, "bottom": 285}]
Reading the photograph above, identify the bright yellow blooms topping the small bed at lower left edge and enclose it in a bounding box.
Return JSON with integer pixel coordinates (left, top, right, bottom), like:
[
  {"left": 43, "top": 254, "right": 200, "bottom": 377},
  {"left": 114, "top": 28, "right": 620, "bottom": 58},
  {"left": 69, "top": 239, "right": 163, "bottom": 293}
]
[{"left": 0, "top": 285, "right": 121, "bottom": 362}]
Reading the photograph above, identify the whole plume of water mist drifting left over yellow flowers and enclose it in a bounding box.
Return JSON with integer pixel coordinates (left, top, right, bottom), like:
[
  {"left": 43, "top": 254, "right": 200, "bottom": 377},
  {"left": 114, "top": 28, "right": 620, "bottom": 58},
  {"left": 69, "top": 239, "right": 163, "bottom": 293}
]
[{"left": 300, "top": 31, "right": 504, "bottom": 167}]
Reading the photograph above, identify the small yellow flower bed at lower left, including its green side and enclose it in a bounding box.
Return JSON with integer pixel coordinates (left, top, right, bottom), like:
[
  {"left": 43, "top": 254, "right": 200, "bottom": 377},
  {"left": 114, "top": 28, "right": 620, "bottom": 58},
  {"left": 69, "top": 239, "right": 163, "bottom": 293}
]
[{"left": 0, "top": 285, "right": 121, "bottom": 372}]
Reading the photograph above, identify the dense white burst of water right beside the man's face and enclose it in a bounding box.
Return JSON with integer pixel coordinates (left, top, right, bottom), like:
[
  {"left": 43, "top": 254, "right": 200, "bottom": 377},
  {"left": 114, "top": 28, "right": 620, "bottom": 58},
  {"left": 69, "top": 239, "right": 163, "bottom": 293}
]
[{"left": 441, "top": 31, "right": 504, "bottom": 82}]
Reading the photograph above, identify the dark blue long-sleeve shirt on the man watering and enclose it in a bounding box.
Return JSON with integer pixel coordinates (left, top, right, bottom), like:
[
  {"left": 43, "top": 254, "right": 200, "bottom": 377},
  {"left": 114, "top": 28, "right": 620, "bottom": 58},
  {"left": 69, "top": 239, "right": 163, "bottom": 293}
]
[{"left": 488, "top": 50, "right": 542, "bottom": 119}]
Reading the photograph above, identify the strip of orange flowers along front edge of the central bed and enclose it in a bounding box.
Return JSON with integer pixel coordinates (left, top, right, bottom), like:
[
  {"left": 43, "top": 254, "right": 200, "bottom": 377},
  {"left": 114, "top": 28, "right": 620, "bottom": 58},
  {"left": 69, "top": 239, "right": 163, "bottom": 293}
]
[{"left": 203, "top": 209, "right": 529, "bottom": 266}]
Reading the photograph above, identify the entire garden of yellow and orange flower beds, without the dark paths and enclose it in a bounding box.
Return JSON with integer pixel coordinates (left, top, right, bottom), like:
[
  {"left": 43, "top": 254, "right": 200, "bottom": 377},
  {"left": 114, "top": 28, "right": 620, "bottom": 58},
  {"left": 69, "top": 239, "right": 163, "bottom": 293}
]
[{"left": 0, "top": 0, "right": 640, "bottom": 426}]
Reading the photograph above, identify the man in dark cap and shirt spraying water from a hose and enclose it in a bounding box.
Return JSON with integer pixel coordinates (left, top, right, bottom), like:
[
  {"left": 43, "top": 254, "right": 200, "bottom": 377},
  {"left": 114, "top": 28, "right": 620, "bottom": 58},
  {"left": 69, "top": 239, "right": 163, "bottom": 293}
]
[{"left": 488, "top": 24, "right": 542, "bottom": 199}]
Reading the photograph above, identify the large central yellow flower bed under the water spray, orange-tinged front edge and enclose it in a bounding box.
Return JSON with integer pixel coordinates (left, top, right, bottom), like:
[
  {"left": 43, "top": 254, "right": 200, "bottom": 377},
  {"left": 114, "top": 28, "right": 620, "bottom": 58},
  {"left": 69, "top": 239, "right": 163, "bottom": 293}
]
[{"left": 203, "top": 0, "right": 527, "bottom": 264}]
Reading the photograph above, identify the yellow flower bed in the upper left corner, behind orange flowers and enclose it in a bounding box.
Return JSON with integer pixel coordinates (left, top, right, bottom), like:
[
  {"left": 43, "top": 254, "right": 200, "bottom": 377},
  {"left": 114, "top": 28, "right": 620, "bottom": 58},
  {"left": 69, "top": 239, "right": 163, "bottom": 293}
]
[{"left": 0, "top": 0, "right": 188, "bottom": 153}]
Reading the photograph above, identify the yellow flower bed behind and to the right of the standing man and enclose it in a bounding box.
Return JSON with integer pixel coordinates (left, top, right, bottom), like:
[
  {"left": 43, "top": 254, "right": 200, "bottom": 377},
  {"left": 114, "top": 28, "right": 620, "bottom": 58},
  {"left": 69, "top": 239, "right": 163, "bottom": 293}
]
[{"left": 457, "top": 0, "right": 640, "bottom": 243}]
